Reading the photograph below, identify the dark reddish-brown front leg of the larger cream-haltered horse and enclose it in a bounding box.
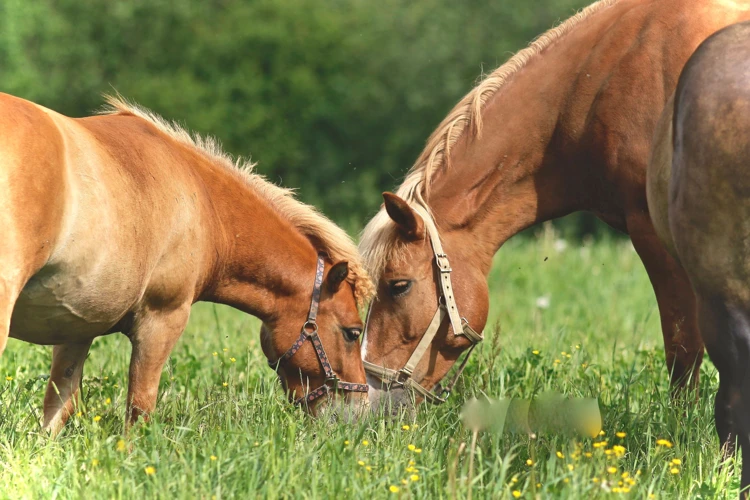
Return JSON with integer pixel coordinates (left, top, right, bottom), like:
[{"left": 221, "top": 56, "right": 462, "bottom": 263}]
[{"left": 627, "top": 213, "right": 703, "bottom": 396}]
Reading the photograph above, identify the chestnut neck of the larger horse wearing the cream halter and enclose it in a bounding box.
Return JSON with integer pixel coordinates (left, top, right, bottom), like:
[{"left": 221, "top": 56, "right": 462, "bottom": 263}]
[{"left": 427, "top": 3, "right": 624, "bottom": 274}]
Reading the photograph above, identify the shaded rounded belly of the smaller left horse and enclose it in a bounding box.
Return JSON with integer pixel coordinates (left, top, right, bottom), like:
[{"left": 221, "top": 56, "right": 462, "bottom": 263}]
[{"left": 10, "top": 265, "right": 139, "bottom": 344}]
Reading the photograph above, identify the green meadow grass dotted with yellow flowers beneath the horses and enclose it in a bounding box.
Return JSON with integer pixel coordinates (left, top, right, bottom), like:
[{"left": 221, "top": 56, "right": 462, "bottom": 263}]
[{"left": 0, "top": 225, "right": 739, "bottom": 499}]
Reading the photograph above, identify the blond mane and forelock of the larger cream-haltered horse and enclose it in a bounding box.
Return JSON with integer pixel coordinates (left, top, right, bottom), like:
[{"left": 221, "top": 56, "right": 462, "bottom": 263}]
[{"left": 359, "top": 0, "right": 619, "bottom": 282}]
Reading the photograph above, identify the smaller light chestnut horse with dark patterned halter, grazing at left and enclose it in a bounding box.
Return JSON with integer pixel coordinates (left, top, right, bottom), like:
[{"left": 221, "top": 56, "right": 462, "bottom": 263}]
[{"left": 0, "top": 94, "right": 372, "bottom": 432}]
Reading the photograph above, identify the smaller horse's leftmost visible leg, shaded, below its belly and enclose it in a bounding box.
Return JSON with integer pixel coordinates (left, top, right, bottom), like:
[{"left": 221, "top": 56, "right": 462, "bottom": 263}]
[{"left": 43, "top": 340, "right": 92, "bottom": 436}]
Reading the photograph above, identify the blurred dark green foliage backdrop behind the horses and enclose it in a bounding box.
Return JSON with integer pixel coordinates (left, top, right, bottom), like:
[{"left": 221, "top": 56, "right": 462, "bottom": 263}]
[{"left": 0, "top": 0, "right": 605, "bottom": 237}]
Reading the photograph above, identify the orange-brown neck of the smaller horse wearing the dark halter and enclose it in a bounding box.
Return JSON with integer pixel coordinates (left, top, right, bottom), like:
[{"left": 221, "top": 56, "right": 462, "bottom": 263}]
[{"left": 201, "top": 169, "right": 317, "bottom": 324}]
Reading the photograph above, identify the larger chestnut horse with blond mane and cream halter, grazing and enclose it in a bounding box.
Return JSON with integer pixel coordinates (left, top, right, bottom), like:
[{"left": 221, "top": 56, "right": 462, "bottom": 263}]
[{"left": 360, "top": 0, "right": 750, "bottom": 408}]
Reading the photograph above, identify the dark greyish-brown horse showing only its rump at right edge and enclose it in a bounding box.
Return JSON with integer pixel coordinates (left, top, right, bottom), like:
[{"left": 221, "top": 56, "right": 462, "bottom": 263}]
[{"left": 647, "top": 22, "right": 750, "bottom": 498}]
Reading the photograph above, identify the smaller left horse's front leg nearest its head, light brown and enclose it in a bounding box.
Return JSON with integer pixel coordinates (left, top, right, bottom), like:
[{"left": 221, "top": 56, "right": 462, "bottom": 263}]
[{"left": 127, "top": 304, "right": 190, "bottom": 426}]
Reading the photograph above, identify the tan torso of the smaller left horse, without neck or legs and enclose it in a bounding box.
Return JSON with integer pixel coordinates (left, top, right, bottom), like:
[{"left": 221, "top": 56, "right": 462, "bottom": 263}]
[{"left": 0, "top": 96, "right": 214, "bottom": 343}]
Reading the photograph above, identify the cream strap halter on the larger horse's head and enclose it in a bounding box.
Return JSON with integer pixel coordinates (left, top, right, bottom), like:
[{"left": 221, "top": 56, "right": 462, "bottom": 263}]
[{"left": 362, "top": 205, "right": 484, "bottom": 404}]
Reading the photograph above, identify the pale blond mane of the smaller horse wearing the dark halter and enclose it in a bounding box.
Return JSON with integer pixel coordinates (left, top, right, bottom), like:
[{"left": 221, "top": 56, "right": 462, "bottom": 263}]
[{"left": 99, "top": 94, "right": 375, "bottom": 305}]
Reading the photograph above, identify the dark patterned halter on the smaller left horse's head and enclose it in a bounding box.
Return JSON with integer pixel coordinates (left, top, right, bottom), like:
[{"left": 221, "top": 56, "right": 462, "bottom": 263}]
[{"left": 268, "top": 253, "right": 369, "bottom": 405}]
